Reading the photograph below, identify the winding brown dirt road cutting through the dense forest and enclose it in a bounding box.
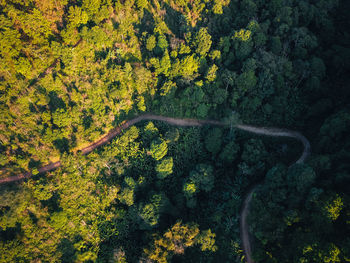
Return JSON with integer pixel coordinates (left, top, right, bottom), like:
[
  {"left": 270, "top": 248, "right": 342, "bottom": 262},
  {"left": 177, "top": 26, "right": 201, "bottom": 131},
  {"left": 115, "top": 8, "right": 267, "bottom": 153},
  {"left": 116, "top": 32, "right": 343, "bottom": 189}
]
[{"left": 0, "top": 114, "right": 311, "bottom": 263}]
